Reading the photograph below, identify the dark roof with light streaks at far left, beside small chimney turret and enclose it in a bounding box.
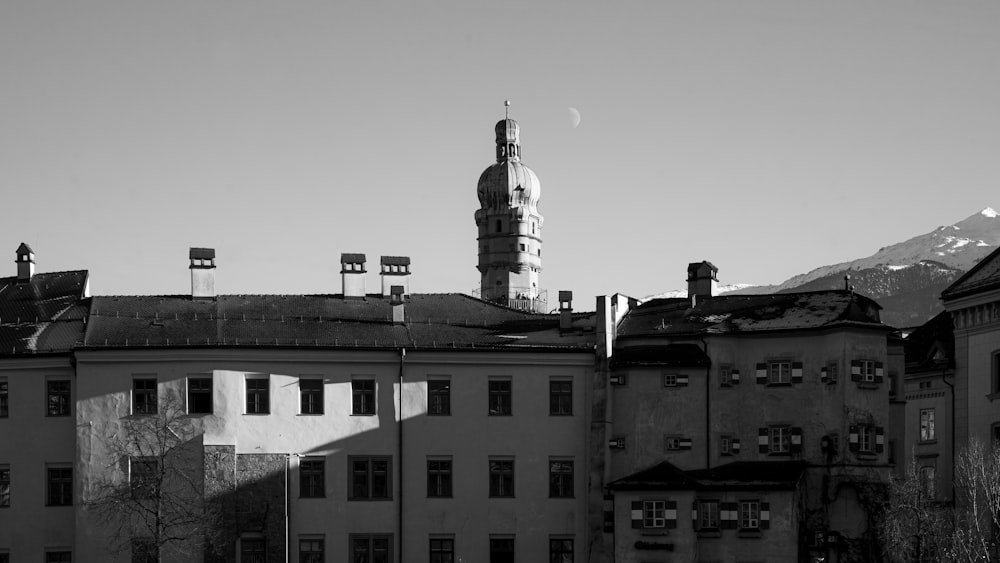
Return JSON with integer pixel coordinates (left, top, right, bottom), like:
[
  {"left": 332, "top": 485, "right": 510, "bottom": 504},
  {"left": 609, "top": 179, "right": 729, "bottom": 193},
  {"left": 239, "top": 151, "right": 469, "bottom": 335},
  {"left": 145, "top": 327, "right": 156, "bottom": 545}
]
[{"left": 0, "top": 270, "right": 89, "bottom": 356}]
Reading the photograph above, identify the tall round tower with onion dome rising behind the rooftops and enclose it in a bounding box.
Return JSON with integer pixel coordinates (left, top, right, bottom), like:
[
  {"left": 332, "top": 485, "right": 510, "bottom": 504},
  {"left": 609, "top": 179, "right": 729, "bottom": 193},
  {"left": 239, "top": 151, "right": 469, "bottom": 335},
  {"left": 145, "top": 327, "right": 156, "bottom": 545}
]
[{"left": 476, "top": 102, "right": 546, "bottom": 312}]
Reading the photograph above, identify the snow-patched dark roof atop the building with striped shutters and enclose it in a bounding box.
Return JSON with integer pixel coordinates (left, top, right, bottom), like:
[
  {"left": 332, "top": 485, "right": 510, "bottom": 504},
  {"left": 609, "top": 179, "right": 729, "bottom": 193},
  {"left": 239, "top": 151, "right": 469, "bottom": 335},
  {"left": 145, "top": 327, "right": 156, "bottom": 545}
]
[{"left": 618, "top": 290, "right": 890, "bottom": 338}]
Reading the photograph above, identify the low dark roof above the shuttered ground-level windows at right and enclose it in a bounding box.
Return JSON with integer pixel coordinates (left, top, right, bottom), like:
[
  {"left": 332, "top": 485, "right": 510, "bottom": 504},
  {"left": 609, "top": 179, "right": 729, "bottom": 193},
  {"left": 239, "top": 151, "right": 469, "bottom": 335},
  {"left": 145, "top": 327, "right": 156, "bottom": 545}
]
[{"left": 608, "top": 461, "right": 806, "bottom": 491}]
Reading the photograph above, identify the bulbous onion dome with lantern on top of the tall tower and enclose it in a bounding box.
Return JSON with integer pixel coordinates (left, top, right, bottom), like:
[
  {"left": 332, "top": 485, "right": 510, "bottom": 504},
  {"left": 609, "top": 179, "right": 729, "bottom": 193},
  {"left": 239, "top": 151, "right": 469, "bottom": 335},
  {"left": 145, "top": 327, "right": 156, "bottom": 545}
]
[{"left": 477, "top": 119, "right": 542, "bottom": 210}]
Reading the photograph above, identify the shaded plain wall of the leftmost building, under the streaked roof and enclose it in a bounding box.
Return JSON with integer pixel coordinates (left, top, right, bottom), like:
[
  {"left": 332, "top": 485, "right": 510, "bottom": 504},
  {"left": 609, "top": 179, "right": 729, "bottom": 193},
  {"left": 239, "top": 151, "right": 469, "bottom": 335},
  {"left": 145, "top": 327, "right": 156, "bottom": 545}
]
[{"left": 0, "top": 356, "right": 79, "bottom": 561}]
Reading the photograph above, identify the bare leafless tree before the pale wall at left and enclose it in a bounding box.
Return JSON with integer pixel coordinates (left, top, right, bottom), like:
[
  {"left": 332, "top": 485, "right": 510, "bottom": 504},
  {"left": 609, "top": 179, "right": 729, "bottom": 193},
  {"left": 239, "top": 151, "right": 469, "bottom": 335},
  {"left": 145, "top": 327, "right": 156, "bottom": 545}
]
[{"left": 85, "top": 391, "right": 218, "bottom": 563}]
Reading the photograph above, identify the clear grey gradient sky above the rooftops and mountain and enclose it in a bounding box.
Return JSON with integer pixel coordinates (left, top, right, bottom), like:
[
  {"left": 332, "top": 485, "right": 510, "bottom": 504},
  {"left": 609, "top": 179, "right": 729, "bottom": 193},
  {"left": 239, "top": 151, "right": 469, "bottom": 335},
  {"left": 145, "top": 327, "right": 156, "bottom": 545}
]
[{"left": 0, "top": 0, "right": 1000, "bottom": 310}]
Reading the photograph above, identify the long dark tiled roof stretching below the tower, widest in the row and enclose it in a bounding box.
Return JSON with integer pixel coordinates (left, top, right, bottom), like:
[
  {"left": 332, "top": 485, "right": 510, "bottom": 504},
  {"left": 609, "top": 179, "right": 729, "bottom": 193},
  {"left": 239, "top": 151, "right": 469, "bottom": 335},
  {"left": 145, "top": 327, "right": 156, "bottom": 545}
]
[{"left": 85, "top": 293, "right": 595, "bottom": 352}]
